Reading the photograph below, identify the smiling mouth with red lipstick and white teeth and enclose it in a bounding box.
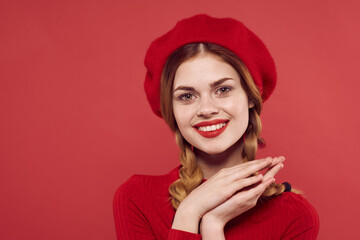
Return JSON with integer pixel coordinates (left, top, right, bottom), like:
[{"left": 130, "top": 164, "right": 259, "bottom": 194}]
[{"left": 193, "top": 119, "right": 229, "bottom": 138}]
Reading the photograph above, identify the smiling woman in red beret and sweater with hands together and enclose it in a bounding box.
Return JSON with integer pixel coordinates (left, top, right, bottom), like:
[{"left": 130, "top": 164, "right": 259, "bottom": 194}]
[{"left": 114, "top": 14, "right": 319, "bottom": 240}]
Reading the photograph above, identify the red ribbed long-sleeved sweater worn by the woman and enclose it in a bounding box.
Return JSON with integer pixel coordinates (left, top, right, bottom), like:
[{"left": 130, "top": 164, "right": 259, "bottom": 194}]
[{"left": 114, "top": 166, "right": 319, "bottom": 240}]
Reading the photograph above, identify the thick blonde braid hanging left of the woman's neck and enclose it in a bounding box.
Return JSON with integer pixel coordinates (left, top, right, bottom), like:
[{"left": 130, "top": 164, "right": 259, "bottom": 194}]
[{"left": 169, "top": 130, "right": 203, "bottom": 209}]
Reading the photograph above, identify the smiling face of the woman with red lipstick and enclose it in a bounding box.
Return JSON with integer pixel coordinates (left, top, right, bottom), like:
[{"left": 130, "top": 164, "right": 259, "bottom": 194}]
[{"left": 173, "top": 54, "right": 253, "bottom": 154}]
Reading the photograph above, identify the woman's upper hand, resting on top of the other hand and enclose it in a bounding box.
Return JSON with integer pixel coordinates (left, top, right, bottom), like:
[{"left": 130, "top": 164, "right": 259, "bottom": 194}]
[{"left": 173, "top": 157, "right": 284, "bottom": 233}]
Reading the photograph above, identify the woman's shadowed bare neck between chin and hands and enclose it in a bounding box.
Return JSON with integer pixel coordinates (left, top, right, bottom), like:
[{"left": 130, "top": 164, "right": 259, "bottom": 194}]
[{"left": 194, "top": 138, "right": 244, "bottom": 179}]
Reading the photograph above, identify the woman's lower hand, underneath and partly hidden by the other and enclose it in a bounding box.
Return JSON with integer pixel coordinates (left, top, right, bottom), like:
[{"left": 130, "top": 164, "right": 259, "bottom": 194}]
[{"left": 200, "top": 157, "right": 285, "bottom": 237}]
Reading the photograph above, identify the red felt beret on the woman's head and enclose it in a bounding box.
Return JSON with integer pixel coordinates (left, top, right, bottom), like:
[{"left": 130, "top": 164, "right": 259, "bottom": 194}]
[{"left": 144, "top": 14, "right": 276, "bottom": 117}]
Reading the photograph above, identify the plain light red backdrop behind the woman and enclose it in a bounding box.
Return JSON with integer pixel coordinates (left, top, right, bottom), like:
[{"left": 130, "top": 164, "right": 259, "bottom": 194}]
[{"left": 0, "top": 0, "right": 360, "bottom": 240}]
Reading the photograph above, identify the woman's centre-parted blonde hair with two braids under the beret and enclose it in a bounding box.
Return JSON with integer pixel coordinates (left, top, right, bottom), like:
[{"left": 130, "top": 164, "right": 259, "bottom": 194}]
[{"left": 160, "top": 43, "right": 296, "bottom": 209}]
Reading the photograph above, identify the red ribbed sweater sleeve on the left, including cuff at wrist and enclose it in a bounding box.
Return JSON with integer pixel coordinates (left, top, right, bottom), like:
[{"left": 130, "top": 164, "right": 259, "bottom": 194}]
[{"left": 113, "top": 175, "right": 201, "bottom": 240}]
